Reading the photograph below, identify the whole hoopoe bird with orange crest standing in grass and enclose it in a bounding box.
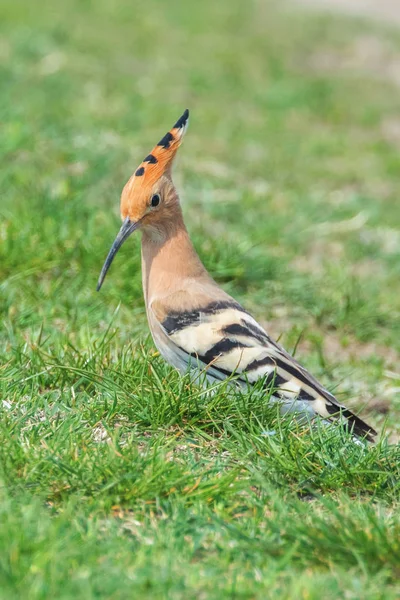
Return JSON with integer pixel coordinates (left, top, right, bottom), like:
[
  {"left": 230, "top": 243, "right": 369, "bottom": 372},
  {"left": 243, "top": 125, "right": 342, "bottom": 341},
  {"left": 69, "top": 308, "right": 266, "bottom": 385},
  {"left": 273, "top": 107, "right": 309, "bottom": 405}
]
[{"left": 97, "top": 110, "right": 376, "bottom": 441}]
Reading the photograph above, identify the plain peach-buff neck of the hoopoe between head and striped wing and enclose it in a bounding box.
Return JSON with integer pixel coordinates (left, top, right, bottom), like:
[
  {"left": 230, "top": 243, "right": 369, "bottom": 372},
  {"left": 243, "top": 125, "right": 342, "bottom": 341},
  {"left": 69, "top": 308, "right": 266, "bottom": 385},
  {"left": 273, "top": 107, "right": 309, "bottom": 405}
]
[{"left": 142, "top": 208, "right": 211, "bottom": 305}]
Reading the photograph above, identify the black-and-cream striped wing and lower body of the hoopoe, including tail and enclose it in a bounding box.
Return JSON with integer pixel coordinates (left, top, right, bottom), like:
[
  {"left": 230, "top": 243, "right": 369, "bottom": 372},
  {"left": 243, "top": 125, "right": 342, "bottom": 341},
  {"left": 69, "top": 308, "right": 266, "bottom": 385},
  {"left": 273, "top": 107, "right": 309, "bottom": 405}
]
[{"left": 150, "top": 292, "right": 376, "bottom": 439}]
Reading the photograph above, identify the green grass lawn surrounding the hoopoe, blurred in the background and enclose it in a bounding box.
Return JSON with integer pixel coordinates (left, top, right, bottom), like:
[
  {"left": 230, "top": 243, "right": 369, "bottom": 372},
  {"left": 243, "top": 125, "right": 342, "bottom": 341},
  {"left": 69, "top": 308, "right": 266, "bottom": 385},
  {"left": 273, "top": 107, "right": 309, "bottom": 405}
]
[{"left": 0, "top": 0, "right": 400, "bottom": 600}]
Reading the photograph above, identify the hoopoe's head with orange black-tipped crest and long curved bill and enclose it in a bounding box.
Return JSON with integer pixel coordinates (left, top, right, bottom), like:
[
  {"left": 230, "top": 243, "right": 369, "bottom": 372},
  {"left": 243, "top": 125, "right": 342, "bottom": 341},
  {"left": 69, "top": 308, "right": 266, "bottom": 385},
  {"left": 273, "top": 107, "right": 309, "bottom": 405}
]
[{"left": 97, "top": 109, "right": 189, "bottom": 291}]
